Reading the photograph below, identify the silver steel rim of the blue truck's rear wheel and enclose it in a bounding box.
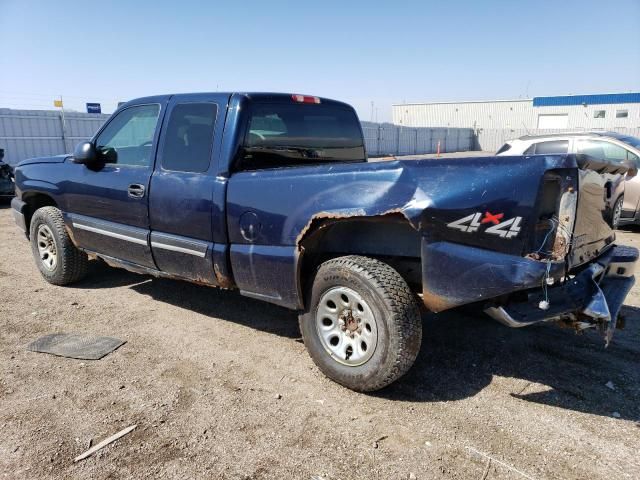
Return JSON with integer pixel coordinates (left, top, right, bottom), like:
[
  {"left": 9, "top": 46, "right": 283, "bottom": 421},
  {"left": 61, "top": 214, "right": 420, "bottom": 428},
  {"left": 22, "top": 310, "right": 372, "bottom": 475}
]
[{"left": 316, "top": 287, "right": 378, "bottom": 367}]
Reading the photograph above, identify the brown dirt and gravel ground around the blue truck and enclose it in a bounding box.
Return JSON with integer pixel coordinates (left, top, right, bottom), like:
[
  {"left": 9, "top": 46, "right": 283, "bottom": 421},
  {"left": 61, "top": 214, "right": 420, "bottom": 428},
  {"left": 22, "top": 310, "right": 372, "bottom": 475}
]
[{"left": 0, "top": 207, "right": 640, "bottom": 480}]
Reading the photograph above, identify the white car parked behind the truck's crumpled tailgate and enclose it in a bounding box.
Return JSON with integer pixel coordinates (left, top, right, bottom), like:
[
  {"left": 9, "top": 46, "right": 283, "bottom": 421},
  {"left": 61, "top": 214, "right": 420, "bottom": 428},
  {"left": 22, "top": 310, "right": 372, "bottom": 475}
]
[{"left": 496, "top": 131, "right": 640, "bottom": 227}]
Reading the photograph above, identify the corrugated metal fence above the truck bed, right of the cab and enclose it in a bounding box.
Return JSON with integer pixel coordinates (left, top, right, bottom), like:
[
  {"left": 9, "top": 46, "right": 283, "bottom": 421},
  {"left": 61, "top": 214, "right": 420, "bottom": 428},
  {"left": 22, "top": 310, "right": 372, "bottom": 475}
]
[{"left": 362, "top": 122, "right": 474, "bottom": 156}]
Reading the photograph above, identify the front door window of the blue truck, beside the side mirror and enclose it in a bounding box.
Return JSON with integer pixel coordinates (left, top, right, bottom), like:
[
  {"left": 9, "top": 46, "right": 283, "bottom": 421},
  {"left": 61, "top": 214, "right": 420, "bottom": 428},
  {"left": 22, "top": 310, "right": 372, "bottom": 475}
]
[{"left": 96, "top": 104, "right": 160, "bottom": 167}]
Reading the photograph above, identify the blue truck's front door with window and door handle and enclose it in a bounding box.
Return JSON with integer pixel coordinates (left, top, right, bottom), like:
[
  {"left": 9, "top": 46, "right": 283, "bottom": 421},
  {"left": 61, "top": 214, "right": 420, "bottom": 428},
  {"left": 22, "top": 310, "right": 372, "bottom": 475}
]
[{"left": 64, "top": 98, "right": 166, "bottom": 268}]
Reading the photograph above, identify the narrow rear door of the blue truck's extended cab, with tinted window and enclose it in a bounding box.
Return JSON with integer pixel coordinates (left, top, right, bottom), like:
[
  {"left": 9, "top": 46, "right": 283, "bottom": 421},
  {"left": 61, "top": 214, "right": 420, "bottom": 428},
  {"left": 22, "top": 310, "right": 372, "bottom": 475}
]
[{"left": 149, "top": 94, "right": 228, "bottom": 285}]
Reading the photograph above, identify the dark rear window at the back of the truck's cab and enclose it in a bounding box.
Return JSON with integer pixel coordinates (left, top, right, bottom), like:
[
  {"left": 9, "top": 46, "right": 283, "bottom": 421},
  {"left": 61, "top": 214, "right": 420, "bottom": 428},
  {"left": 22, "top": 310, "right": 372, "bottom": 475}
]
[{"left": 242, "top": 103, "right": 366, "bottom": 170}]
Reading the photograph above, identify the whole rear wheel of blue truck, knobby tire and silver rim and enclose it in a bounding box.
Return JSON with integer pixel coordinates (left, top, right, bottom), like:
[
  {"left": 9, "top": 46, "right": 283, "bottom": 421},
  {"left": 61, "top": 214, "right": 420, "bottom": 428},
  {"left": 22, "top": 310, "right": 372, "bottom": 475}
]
[{"left": 300, "top": 255, "right": 422, "bottom": 392}]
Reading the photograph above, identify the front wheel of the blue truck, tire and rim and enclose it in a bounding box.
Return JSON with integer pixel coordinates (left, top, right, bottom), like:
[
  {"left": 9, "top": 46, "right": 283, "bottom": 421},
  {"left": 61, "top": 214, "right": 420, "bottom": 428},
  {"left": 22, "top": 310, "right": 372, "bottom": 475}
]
[{"left": 29, "top": 207, "right": 89, "bottom": 285}]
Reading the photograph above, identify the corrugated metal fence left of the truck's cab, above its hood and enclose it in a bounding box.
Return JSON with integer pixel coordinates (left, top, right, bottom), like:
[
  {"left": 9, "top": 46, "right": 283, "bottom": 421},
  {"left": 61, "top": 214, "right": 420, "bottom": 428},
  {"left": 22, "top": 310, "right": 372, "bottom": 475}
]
[{"left": 0, "top": 108, "right": 109, "bottom": 165}]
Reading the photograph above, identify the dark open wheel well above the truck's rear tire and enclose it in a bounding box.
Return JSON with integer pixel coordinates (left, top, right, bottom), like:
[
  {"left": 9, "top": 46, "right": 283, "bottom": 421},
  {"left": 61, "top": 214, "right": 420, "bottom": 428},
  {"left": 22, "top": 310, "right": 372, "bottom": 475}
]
[{"left": 297, "top": 212, "right": 422, "bottom": 304}]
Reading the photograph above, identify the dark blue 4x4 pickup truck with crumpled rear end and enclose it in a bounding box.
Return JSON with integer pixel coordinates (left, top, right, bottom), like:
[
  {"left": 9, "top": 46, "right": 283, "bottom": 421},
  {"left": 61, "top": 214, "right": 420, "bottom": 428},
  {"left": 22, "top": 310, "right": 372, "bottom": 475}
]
[{"left": 12, "top": 93, "right": 638, "bottom": 391}]
